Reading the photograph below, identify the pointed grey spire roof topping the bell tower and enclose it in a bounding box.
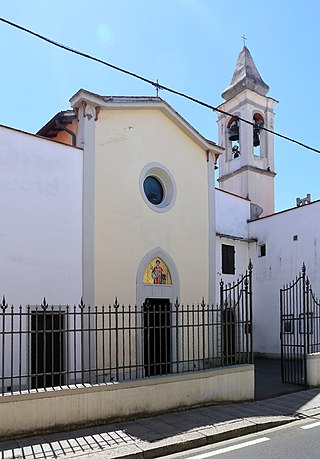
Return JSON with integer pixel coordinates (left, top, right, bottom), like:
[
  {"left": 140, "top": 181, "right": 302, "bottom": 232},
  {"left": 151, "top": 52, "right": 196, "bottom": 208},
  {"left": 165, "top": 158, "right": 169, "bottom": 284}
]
[{"left": 221, "top": 46, "right": 270, "bottom": 100}]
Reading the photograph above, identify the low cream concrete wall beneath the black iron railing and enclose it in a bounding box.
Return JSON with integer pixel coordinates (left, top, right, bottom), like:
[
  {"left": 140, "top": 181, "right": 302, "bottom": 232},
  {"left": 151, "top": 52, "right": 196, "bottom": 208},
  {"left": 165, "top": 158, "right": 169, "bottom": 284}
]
[{"left": 0, "top": 365, "right": 254, "bottom": 439}]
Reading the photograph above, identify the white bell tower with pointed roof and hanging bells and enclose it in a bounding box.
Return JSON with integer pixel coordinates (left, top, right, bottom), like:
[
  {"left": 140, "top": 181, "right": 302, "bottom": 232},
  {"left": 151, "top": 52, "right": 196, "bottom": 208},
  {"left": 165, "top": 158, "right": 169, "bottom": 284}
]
[{"left": 218, "top": 46, "right": 277, "bottom": 218}]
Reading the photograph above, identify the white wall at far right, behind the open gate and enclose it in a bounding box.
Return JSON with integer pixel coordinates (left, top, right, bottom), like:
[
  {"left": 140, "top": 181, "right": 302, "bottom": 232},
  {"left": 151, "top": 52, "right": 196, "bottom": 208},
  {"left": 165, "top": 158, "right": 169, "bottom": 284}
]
[{"left": 249, "top": 201, "right": 320, "bottom": 355}]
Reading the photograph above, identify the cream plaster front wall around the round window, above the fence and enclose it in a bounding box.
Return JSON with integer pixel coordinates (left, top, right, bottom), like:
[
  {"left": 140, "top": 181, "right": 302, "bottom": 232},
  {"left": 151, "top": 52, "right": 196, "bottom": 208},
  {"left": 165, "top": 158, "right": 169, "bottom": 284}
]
[{"left": 94, "top": 109, "right": 209, "bottom": 304}]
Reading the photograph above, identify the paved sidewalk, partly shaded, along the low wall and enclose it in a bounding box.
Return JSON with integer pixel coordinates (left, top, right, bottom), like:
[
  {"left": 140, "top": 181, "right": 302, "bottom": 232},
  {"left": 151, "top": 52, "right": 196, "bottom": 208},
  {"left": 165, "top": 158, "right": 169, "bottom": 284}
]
[{"left": 0, "top": 388, "right": 320, "bottom": 459}]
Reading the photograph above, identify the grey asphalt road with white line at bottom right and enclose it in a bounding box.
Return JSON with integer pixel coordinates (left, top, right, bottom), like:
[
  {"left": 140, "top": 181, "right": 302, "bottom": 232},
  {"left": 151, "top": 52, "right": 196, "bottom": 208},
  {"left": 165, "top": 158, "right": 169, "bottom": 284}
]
[{"left": 167, "top": 418, "right": 320, "bottom": 459}]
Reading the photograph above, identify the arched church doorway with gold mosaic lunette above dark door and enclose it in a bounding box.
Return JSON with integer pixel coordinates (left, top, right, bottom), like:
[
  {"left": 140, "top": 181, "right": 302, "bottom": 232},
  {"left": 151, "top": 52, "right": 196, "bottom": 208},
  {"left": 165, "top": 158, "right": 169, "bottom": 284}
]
[{"left": 137, "top": 252, "right": 179, "bottom": 376}]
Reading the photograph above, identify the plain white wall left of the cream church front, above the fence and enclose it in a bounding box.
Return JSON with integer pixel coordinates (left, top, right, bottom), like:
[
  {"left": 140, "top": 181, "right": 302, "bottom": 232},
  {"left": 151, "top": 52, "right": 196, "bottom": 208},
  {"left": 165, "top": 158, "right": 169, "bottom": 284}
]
[{"left": 0, "top": 126, "right": 82, "bottom": 304}]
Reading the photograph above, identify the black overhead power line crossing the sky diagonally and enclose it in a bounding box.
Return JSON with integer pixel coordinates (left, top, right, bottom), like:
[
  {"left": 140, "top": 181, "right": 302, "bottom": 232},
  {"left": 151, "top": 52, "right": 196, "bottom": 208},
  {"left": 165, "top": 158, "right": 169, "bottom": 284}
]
[{"left": 0, "top": 17, "right": 320, "bottom": 153}]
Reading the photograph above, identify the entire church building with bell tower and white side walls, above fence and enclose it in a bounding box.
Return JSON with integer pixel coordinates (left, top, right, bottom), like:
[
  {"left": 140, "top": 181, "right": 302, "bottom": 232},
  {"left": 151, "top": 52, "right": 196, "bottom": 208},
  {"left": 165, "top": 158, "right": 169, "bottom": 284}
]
[{"left": 0, "top": 47, "right": 320, "bottom": 366}]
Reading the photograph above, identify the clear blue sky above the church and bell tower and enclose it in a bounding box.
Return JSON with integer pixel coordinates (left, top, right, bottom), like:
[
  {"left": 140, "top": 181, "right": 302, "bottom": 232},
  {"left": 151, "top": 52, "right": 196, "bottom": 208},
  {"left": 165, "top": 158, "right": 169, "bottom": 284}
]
[{"left": 0, "top": 0, "right": 320, "bottom": 210}]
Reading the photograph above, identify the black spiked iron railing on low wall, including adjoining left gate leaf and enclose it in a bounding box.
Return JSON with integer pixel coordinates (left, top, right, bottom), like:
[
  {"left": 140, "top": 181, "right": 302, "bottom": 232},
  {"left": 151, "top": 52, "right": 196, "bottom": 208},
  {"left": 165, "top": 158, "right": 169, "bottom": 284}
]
[{"left": 0, "top": 273, "right": 252, "bottom": 395}]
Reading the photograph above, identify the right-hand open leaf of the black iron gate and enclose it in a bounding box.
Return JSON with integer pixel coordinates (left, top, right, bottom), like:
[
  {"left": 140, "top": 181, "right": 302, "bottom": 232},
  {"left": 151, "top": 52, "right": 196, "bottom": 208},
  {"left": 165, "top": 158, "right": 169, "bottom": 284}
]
[{"left": 280, "top": 264, "right": 320, "bottom": 386}]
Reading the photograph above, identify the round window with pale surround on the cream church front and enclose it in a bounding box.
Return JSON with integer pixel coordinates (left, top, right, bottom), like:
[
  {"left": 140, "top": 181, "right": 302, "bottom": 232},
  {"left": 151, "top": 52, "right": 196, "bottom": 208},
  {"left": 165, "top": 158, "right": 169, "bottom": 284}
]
[{"left": 139, "top": 163, "right": 176, "bottom": 212}]
